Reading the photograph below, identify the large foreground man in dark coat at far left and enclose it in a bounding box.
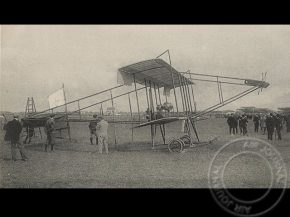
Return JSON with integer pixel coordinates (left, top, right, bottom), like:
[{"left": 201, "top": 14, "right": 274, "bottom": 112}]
[{"left": 6, "top": 115, "right": 28, "bottom": 161}]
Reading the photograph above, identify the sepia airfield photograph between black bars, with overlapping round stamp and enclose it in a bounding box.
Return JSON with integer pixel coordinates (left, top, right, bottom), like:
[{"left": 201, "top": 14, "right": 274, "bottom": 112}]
[{"left": 0, "top": 25, "right": 290, "bottom": 201}]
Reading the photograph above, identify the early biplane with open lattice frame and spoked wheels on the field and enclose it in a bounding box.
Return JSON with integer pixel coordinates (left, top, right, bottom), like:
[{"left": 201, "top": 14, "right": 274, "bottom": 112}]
[{"left": 23, "top": 50, "right": 269, "bottom": 152}]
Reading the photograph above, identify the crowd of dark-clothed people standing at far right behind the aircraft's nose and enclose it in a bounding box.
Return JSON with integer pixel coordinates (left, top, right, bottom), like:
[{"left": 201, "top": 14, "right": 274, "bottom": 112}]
[{"left": 227, "top": 113, "right": 290, "bottom": 140}]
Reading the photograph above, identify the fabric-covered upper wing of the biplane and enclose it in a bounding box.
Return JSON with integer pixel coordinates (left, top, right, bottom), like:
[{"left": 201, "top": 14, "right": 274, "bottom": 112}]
[{"left": 119, "top": 59, "right": 193, "bottom": 89}]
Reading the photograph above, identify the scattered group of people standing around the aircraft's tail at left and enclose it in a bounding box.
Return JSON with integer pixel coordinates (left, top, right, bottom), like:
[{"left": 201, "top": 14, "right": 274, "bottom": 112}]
[{"left": 3, "top": 114, "right": 109, "bottom": 161}]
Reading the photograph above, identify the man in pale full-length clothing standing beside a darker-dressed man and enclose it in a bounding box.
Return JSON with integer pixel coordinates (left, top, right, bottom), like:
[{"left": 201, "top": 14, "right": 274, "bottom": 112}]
[{"left": 97, "top": 117, "right": 109, "bottom": 154}]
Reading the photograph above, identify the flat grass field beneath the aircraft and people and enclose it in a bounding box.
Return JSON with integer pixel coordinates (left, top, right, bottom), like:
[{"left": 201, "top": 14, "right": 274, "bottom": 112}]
[{"left": 0, "top": 119, "right": 290, "bottom": 188}]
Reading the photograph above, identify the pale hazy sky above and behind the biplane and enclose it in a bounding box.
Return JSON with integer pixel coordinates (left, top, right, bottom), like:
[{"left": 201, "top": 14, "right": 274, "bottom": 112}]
[{"left": 0, "top": 25, "right": 290, "bottom": 112}]
